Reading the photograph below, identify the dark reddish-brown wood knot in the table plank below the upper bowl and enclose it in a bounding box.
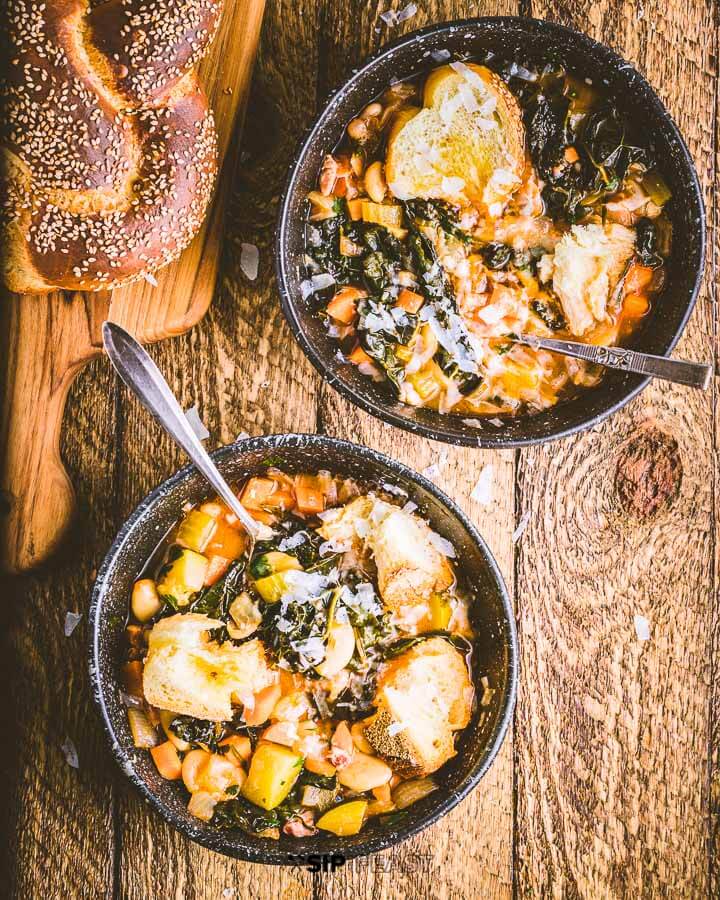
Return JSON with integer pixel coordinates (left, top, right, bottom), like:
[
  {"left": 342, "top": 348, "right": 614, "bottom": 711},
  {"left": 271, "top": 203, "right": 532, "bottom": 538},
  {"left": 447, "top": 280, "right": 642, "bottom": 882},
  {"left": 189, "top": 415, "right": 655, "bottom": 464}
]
[{"left": 615, "top": 426, "right": 683, "bottom": 519}]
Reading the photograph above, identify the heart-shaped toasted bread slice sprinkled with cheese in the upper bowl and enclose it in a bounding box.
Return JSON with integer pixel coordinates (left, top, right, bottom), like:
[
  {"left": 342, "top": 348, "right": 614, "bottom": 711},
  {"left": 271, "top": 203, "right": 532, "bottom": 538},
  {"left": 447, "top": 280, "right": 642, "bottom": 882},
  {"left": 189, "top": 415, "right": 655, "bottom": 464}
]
[{"left": 385, "top": 63, "right": 526, "bottom": 217}]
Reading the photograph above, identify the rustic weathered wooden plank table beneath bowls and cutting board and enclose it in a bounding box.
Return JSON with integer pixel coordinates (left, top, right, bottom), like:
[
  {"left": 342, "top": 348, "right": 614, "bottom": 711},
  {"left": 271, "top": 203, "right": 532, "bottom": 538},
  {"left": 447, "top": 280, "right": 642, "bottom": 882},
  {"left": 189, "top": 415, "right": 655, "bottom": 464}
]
[{"left": 0, "top": 0, "right": 720, "bottom": 900}]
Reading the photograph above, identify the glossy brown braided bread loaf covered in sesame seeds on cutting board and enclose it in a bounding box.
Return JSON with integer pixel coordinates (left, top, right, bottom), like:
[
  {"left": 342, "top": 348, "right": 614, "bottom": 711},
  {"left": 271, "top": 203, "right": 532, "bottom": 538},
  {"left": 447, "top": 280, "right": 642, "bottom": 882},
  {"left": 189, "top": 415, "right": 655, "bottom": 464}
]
[{"left": 2, "top": 0, "right": 222, "bottom": 293}]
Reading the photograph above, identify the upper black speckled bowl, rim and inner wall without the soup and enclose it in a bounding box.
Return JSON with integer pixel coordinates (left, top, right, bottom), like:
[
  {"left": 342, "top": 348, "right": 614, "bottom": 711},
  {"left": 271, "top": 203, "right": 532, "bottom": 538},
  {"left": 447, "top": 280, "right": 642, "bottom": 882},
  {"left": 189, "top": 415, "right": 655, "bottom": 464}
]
[{"left": 277, "top": 17, "right": 705, "bottom": 447}]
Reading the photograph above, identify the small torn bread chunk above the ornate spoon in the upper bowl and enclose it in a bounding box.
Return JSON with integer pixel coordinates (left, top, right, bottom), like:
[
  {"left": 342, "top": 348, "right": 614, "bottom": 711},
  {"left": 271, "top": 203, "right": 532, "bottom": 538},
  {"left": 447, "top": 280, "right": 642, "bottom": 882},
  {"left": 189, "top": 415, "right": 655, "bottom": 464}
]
[{"left": 542, "top": 224, "right": 635, "bottom": 335}]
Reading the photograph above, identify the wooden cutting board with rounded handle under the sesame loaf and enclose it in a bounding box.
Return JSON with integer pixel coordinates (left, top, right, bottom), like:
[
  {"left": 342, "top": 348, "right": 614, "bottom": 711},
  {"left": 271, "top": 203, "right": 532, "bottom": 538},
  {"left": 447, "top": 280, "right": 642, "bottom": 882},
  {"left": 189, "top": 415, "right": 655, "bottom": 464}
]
[{"left": 0, "top": 0, "right": 265, "bottom": 572}]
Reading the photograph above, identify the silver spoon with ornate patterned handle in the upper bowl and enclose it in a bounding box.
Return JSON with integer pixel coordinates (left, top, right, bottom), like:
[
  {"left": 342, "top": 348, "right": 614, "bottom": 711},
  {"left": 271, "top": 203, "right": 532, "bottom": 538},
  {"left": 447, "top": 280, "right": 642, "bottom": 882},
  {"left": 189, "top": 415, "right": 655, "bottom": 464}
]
[{"left": 510, "top": 334, "right": 713, "bottom": 390}]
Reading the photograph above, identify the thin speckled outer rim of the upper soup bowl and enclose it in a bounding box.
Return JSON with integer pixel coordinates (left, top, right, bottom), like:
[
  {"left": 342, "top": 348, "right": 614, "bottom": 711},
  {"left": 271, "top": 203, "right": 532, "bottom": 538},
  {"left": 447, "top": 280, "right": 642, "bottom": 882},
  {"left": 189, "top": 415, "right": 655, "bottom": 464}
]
[{"left": 274, "top": 16, "right": 707, "bottom": 448}]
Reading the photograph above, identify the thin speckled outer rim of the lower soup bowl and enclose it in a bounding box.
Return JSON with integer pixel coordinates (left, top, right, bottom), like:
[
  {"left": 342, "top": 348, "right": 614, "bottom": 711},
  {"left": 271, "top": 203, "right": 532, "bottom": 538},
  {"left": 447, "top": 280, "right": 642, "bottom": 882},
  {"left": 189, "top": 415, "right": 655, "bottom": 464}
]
[{"left": 88, "top": 433, "right": 519, "bottom": 865}]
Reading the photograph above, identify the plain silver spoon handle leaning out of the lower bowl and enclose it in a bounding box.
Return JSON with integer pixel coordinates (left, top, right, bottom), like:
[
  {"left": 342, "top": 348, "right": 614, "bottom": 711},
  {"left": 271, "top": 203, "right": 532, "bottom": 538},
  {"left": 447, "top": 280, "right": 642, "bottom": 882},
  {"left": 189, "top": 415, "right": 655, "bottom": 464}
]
[{"left": 103, "top": 322, "right": 260, "bottom": 540}]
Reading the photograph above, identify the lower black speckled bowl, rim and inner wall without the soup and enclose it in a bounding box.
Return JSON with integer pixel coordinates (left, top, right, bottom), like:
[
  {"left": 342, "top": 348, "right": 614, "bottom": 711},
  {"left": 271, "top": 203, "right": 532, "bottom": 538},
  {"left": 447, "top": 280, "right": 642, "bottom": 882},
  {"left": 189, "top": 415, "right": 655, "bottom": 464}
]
[{"left": 90, "top": 435, "right": 518, "bottom": 864}]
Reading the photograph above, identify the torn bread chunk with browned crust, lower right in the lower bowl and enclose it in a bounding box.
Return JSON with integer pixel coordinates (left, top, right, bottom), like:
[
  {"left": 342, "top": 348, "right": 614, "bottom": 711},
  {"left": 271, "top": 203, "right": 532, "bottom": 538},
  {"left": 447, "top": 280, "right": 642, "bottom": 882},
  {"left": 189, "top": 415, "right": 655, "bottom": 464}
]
[{"left": 364, "top": 638, "right": 473, "bottom": 775}]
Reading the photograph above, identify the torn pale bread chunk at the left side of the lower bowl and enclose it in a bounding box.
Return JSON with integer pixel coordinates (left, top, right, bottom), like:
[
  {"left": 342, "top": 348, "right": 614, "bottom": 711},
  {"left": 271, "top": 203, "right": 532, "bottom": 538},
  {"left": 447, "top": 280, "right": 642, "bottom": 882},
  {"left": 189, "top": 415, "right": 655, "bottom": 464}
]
[{"left": 143, "top": 613, "right": 277, "bottom": 722}]
